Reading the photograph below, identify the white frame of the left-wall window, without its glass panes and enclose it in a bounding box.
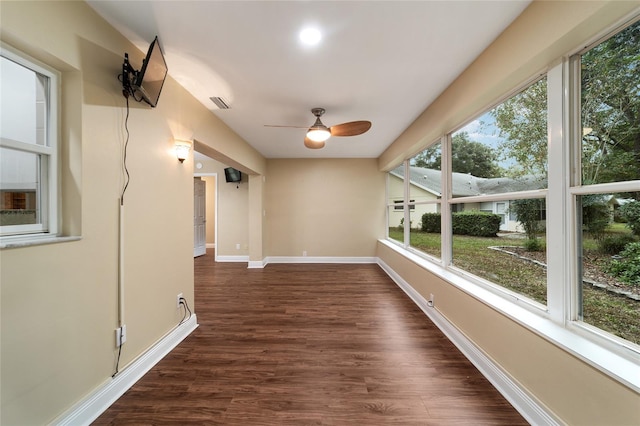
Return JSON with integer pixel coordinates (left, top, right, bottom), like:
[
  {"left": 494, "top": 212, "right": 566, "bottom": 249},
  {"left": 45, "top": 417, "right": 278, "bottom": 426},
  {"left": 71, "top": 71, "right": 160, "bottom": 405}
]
[{"left": 0, "top": 43, "right": 61, "bottom": 241}]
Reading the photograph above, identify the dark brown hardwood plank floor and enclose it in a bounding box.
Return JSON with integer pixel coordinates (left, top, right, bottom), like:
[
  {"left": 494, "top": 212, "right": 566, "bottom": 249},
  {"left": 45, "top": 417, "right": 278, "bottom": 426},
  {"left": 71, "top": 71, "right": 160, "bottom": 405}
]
[{"left": 94, "top": 251, "right": 527, "bottom": 425}]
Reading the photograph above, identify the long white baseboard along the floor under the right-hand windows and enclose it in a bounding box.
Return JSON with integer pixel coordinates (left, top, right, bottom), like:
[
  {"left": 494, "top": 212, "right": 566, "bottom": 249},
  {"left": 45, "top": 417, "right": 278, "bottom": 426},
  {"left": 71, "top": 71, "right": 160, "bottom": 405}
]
[{"left": 378, "top": 259, "right": 562, "bottom": 425}]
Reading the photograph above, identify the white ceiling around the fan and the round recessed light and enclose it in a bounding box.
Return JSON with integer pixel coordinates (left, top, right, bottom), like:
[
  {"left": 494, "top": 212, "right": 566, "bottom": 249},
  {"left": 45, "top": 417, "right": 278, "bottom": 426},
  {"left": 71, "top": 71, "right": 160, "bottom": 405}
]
[{"left": 88, "top": 0, "right": 529, "bottom": 158}]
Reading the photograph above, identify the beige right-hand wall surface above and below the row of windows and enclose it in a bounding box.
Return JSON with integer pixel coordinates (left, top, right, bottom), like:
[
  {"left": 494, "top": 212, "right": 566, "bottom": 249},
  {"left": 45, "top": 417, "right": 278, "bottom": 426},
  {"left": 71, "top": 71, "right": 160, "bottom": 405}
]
[{"left": 377, "top": 1, "right": 640, "bottom": 425}]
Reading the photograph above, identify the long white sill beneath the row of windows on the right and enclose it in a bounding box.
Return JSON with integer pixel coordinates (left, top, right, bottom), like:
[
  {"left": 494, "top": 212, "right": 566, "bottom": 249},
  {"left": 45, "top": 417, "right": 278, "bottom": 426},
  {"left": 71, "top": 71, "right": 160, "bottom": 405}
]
[{"left": 378, "top": 240, "right": 640, "bottom": 393}]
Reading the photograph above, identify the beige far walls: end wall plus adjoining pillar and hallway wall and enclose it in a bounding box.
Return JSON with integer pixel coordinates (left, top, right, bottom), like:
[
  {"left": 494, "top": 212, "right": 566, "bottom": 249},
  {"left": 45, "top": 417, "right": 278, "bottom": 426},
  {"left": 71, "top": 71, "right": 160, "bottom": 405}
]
[{"left": 196, "top": 159, "right": 385, "bottom": 261}]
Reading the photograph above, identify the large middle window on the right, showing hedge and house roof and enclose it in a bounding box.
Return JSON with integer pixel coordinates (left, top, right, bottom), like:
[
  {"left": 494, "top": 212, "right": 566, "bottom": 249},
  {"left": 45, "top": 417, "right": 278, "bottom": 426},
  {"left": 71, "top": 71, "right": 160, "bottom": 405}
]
[{"left": 450, "top": 78, "right": 548, "bottom": 305}]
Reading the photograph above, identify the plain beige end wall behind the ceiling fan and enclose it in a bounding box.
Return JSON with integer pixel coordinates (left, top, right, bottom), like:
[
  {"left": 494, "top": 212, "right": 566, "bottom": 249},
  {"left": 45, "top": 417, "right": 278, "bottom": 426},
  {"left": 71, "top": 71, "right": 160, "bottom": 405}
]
[{"left": 265, "top": 159, "right": 385, "bottom": 257}]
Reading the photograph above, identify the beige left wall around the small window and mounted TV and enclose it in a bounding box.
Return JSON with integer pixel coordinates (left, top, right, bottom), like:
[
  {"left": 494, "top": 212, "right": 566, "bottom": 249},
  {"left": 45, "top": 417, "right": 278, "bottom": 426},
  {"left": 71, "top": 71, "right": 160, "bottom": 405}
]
[{"left": 0, "top": 1, "right": 266, "bottom": 425}]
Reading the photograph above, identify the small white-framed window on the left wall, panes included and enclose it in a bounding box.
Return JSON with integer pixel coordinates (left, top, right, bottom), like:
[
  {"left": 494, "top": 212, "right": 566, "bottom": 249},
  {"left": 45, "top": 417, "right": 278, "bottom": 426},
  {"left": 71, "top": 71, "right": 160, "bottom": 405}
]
[{"left": 0, "top": 45, "right": 58, "bottom": 237}]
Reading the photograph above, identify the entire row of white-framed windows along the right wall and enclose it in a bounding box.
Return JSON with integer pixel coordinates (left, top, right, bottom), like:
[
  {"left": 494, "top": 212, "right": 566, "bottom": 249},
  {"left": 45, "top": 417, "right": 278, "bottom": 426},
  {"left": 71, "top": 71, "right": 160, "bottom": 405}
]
[{"left": 384, "top": 18, "right": 640, "bottom": 355}]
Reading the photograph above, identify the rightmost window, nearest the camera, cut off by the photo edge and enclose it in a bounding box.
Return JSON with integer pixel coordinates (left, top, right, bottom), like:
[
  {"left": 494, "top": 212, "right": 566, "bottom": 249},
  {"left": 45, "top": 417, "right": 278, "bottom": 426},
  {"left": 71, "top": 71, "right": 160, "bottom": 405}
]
[{"left": 571, "top": 22, "right": 640, "bottom": 344}]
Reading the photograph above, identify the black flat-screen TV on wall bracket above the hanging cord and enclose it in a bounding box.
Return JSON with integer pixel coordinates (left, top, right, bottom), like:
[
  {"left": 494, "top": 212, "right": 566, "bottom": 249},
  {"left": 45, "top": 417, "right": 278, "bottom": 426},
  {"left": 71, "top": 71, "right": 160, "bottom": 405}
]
[{"left": 122, "top": 36, "right": 168, "bottom": 107}]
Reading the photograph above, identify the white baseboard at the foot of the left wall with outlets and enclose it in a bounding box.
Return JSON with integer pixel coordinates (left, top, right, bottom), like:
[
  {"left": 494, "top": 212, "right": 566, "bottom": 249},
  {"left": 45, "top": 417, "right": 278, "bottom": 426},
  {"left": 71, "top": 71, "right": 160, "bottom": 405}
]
[{"left": 51, "top": 314, "right": 198, "bottom": 426}]
